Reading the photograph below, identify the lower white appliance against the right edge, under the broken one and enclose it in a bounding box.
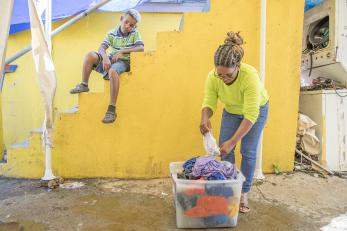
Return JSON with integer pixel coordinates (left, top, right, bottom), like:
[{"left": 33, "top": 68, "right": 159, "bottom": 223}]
[{"left": 299, "top": 90, "right": 347, "bottom": 171}]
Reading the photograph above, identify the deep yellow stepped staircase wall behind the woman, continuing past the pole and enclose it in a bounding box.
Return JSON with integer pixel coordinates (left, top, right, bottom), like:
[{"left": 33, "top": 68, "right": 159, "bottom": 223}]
[{"left": 0, "top": 0, "right": 304, "bottom": 178}]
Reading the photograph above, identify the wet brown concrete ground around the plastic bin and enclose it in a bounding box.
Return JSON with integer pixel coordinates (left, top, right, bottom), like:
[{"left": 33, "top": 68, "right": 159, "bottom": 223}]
[{"left": 0, "top": 173, "right": 347, "bottom": 231}]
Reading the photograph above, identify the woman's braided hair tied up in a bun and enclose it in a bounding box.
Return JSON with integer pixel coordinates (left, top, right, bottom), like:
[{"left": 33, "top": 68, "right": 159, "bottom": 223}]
[{"left": 214, "top": 31, "right": 244, "bottom": 67}]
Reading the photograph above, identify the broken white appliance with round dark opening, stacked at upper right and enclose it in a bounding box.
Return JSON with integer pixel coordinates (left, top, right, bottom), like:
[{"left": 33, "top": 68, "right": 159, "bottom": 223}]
[{"left": 301, "top": 0, "right": 347, "bottom": 86}]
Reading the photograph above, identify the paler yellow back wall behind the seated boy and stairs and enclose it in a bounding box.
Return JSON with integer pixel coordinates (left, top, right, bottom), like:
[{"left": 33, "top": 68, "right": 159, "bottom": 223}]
[{"left": 2, "top": 13, "right": 182, "bottom": 146}]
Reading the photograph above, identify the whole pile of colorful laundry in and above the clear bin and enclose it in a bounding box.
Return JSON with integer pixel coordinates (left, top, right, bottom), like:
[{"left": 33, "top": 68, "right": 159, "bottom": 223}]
[{"left": 176, "top": 155, "right": 239, "bottom": 227}]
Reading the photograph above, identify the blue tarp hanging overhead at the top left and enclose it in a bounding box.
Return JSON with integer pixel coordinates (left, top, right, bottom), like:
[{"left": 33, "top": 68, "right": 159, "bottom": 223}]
[{"left": 10, "top": 0, "right": 142, "bottom": 34}]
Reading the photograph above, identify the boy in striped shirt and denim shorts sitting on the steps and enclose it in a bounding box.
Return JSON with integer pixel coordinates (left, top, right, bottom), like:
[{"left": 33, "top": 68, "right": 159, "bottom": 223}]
[{"left": 70, "top": 9, "right": 144, "bottom": 123}]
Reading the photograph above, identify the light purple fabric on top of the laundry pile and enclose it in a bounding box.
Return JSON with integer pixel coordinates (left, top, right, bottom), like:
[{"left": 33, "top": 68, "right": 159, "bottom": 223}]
[{"left": 192, "top": 155, "right": 237, "bottom": 179}]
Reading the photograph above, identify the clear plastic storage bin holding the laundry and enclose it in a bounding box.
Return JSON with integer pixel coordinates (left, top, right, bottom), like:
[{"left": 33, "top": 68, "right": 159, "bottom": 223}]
[{"left": 170, "top": 162, "right": 245, "bottom": 228}]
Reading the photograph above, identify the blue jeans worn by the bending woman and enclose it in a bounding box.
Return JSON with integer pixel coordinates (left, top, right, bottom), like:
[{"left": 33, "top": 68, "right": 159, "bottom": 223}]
[{"left": 219, "top": 103, "right": 269, "bottom": 193}]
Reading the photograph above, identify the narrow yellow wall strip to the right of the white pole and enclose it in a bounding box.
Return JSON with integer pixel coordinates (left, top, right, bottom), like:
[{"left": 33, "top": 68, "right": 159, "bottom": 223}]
[{"left": 263, "top": 0, "right": 304, "bottom": 171}]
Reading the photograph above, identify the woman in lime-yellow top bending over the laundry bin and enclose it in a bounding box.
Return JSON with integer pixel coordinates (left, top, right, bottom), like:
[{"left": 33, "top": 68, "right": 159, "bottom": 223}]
[{"left": 200, "top": 32, "right": 269, "bottom": 213}]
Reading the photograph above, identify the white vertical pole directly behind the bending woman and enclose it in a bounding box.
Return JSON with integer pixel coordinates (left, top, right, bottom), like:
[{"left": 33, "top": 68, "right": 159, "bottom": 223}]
[{"left": 254, "top": 0, "right": 266, "bottom": 180}]
